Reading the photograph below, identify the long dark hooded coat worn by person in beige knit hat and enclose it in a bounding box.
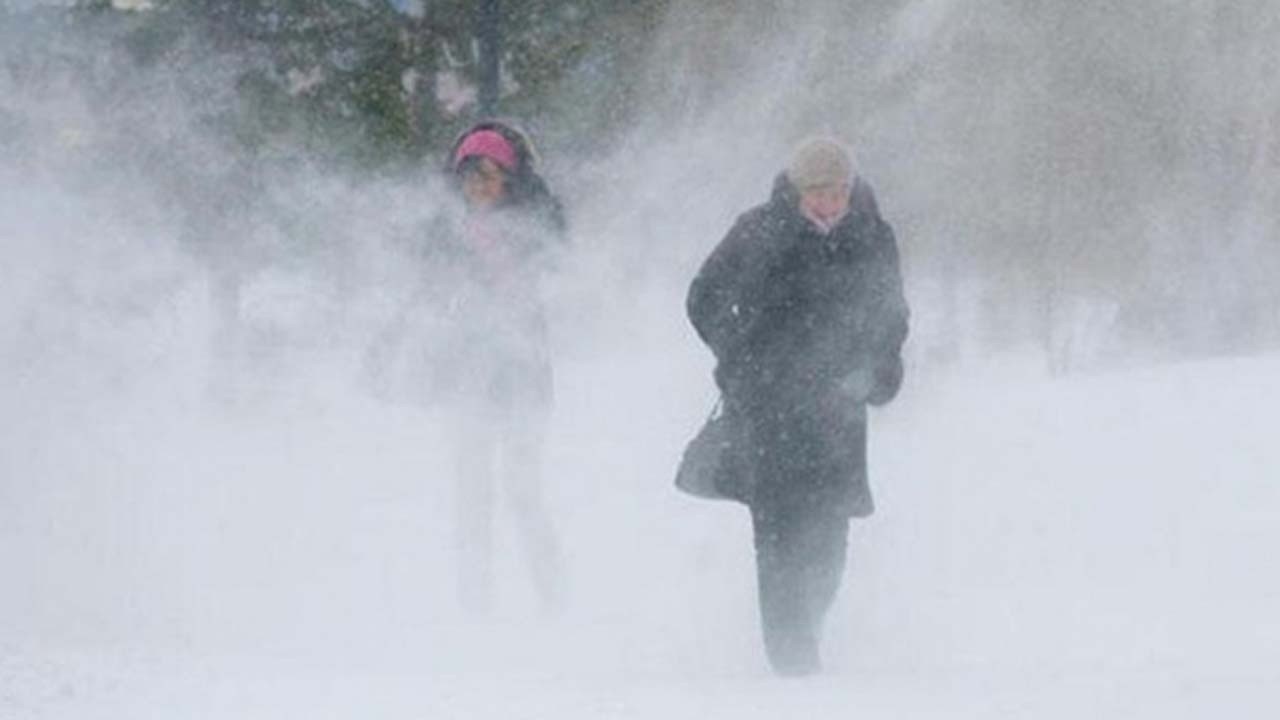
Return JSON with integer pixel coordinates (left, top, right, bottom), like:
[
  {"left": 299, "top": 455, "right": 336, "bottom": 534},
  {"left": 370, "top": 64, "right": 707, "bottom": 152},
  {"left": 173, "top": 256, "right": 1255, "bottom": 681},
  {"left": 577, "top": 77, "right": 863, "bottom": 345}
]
[{"left": 687, "top": 176, "right": 908, "bottom": 516}]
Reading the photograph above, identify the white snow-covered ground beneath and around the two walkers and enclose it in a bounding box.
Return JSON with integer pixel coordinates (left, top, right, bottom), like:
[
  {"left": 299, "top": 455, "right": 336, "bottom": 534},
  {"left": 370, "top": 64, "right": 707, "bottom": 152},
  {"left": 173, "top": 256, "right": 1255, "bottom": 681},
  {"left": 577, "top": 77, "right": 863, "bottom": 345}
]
[{"left": 0, "top": 302, "right": 1280, "bottom": 720}]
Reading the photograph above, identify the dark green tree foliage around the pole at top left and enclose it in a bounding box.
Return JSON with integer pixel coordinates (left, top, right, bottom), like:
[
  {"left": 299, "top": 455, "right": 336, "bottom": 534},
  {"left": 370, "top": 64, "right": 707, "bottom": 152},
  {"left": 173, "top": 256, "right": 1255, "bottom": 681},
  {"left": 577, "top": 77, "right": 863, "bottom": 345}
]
[{"left": 61, "top": 0, "right": 668, "bottom": 169}]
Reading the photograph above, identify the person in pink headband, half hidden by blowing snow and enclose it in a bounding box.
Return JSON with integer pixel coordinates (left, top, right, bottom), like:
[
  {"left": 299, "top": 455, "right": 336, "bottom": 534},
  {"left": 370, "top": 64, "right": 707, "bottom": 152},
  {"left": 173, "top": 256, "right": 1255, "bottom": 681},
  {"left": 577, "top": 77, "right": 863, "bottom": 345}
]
[{"left": 433, "top": 120, "right": 566, "bottom": 614}]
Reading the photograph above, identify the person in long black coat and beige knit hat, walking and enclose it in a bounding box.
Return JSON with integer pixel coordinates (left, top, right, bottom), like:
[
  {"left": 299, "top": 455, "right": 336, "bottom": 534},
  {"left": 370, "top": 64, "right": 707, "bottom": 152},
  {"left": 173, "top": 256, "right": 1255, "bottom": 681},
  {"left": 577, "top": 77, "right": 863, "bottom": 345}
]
[{"left": 687, "top": 140, "right": 908, "bottom": 675}]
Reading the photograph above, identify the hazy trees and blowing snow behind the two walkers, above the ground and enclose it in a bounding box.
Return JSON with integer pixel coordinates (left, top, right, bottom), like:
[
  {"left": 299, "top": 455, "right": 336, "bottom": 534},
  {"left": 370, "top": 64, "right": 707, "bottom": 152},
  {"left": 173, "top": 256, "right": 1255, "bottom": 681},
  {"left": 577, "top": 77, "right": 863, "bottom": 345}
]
[{"left": 0, "top": 0, "right": 1280, "bottom": 381}]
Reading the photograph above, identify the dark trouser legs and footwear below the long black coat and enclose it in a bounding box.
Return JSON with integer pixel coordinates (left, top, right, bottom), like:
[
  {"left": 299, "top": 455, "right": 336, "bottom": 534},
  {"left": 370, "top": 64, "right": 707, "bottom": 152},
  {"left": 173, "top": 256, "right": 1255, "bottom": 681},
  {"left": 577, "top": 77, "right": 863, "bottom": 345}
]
[{"left": 751, "top": 503, "right": 849, "bottom": 675}]
